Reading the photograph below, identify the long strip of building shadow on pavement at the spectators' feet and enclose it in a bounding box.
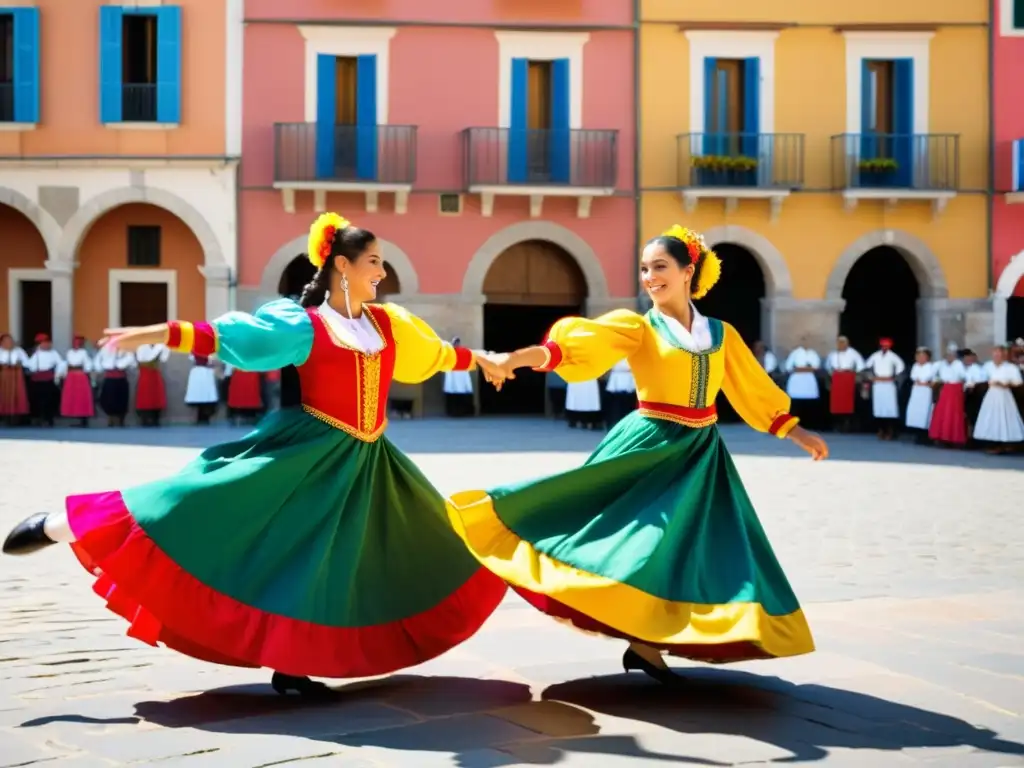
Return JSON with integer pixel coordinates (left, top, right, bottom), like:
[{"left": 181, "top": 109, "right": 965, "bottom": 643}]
[{"left": 0, "top": 418, "right": 1024, "bottom": 471}]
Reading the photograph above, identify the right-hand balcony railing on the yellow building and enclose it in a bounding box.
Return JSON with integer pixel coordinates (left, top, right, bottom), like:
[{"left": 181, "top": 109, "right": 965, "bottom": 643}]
[{"left": 831, "top": 133, "right": 959, "bottom": 191}]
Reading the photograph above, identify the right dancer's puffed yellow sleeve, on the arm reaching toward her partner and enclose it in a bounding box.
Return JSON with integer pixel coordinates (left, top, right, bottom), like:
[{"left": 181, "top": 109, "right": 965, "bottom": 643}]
[{"left": 536, "top": 309, "right": 644, "bottom": 383}]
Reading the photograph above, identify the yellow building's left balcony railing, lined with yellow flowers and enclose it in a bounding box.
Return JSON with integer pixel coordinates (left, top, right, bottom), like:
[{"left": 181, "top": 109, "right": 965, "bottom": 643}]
[{"left": 677, "top": 133, "right": 804, "bottom": 189}]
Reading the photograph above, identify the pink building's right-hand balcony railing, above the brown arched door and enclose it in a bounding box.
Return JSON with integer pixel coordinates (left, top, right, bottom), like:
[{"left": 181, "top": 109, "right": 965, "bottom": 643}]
[{"left": 463, "top": 128, "right": 618, "bottom": 189}]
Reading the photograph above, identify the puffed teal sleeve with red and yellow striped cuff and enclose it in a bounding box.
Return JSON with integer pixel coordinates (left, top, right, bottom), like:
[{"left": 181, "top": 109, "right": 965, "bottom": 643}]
[{"left": 167, "top": 299, "right": 313, "bottom": 372}]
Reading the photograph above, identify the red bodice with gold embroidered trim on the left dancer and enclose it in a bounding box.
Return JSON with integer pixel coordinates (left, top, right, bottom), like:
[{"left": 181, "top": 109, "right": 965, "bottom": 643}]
[{"left": 297, "top": 305, "right": 395, "bottom": 440}]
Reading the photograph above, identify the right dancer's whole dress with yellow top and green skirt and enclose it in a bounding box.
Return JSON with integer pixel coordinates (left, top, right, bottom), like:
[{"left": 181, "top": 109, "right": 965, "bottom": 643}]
[{"left": 449, "top": 310, "right": 814, "bottom": 663}]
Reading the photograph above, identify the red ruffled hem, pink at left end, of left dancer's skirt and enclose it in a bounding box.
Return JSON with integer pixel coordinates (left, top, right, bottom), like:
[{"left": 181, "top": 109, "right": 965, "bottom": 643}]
[{"left": 67, "top": 492, "right": 506, "bottom": 678}]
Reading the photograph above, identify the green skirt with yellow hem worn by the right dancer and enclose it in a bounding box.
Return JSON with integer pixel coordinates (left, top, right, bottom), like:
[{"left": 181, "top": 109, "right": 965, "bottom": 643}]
[{"left": 449, "top": 413, "right": 814, "bottom": 663}]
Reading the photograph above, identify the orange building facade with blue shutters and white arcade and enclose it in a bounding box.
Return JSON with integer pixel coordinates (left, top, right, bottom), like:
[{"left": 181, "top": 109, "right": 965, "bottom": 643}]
[{"left": 0, "top": 0, "right": 243, "bottom": 366}]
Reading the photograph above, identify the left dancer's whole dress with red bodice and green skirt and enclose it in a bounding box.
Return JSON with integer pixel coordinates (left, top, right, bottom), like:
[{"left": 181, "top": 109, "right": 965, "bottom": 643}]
[{"left": 67, "top": 299, "right": 506, "bottom": 678}]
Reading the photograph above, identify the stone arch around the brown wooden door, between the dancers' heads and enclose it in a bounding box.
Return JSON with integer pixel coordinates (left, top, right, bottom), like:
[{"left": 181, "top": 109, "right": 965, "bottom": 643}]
[{"left": 462, "top": 221, "right": 609, "bottom": 302}]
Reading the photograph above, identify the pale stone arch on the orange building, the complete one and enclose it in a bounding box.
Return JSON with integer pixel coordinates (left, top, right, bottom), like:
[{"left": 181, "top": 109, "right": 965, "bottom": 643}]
[{"left": 56, "top": 186, "right": 230, "bottom": 269}]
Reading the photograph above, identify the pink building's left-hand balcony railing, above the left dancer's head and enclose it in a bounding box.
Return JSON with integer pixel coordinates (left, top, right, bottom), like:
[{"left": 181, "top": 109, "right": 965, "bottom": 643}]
[{"left": 273, "top": 123, "right": 416, "bottom": 185}]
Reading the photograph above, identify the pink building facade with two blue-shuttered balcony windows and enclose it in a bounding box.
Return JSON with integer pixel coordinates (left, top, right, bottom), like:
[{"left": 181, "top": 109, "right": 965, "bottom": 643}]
[{"left": 238, "top": 0, "right": 636, "bottom": 415}]
